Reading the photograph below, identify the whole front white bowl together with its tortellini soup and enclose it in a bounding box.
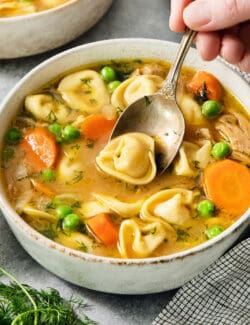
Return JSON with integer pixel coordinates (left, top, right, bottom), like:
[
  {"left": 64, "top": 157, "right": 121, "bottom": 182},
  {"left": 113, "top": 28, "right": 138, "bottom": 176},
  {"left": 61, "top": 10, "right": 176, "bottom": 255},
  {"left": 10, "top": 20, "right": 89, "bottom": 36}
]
[{"left": 0, "top": 39, "right": 250, "bottom": 294}]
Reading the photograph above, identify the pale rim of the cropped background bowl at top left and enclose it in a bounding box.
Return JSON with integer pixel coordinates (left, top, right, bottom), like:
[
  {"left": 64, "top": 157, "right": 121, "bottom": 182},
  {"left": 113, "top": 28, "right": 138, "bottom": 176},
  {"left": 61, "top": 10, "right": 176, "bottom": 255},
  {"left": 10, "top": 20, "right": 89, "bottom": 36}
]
[{"left": 0, "top": 0, "right": 82, "bottom": 21}]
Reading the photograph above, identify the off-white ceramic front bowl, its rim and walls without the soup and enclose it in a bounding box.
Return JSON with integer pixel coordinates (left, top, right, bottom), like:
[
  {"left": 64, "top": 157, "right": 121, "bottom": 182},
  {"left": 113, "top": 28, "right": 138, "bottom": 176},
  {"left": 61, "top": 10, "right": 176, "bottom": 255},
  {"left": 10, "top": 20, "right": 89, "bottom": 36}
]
[{"left": 0, "top": 39, "right": 250, "bottom": 294}]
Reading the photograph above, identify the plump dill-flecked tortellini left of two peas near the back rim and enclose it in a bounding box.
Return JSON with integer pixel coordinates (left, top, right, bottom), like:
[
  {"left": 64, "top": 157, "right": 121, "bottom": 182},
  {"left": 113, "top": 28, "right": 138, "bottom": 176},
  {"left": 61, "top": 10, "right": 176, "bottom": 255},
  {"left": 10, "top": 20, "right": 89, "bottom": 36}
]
[{"left": 58, "top": 70, "right": 110, "bottom": 114}]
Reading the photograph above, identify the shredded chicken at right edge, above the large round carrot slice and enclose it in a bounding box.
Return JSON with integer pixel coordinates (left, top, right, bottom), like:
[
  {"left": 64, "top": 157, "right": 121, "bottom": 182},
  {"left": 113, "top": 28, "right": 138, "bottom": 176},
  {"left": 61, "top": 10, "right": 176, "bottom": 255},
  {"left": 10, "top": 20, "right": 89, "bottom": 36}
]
[{"left": 215, "top": 112, "right": 250, "bottom": 164}]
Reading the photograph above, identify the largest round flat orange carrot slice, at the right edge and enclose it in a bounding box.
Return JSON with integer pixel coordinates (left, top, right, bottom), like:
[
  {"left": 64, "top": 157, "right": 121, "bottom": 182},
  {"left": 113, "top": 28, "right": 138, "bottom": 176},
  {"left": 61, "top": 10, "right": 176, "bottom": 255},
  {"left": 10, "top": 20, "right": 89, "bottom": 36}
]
[{"left": 203, "top": 159, "right": 250, "bottom": 216}]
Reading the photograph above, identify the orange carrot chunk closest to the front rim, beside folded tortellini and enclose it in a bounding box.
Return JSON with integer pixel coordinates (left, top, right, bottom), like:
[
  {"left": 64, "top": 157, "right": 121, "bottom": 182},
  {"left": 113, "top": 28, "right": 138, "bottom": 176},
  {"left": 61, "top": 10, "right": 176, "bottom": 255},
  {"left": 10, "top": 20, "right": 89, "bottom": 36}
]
[{"left": 87, "top": 213, "right": 118, "bottom": 246}]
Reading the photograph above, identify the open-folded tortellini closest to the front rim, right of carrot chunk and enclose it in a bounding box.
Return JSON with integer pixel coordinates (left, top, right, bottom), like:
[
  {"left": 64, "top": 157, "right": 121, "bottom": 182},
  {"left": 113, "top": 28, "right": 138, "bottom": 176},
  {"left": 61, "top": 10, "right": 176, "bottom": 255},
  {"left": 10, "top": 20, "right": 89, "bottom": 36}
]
[{"left": 119, "top": 219, "right": 168, "bottom": 258}]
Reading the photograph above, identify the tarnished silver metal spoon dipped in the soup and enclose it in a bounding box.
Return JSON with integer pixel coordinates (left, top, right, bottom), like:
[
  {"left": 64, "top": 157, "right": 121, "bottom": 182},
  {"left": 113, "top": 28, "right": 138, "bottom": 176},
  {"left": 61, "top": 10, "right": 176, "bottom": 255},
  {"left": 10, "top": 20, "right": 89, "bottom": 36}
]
[{"left": 110, "top": 30, "right": 196, "bottom": 173}]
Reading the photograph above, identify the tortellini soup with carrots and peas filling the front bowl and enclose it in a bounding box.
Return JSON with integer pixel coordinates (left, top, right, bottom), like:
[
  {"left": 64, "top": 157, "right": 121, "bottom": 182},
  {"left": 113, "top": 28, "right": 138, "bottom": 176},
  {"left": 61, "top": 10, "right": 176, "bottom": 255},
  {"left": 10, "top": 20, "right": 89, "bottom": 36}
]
[{"left": 2, "top": 59, "right": 250, "bottom": 258}]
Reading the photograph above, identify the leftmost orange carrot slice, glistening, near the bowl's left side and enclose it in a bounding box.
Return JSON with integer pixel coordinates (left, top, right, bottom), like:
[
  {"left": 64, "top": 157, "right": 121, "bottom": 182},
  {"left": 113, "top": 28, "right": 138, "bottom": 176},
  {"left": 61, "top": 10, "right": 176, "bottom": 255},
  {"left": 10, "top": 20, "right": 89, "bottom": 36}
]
[{"left": 21, "top": 127, "right": 58, "bottom": 172}]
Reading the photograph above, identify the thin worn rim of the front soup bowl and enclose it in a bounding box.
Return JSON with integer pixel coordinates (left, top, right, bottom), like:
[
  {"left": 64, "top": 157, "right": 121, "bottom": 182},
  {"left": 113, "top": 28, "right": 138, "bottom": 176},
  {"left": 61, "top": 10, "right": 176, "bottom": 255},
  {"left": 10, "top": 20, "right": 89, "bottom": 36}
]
[{"left": 0, "top": 38, "right": 250, "bottom": 266}]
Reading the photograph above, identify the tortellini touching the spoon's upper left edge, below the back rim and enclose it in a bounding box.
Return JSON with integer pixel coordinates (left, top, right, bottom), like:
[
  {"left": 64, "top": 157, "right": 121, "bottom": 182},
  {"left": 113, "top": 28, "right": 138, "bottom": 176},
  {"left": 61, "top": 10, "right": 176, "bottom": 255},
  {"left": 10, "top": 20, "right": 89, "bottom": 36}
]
[{"left": 111, "top": 75, "right": 163, "bottom": 110}]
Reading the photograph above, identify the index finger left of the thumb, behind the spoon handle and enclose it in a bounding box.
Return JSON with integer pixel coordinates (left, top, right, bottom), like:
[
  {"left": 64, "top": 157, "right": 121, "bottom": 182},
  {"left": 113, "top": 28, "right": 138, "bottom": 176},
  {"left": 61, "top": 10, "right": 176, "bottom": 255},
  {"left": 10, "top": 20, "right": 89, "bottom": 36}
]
[{"left": 169, "top": 0, "right": 192, "bottom": 32}]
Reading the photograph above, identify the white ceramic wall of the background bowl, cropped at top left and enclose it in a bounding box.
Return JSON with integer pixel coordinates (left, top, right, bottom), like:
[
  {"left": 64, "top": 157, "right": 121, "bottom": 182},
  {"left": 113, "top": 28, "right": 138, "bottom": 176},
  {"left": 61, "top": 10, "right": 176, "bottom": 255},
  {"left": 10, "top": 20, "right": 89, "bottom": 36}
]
[{"left": 0, "top": 0, "right": 112, "bottom": 59}]
